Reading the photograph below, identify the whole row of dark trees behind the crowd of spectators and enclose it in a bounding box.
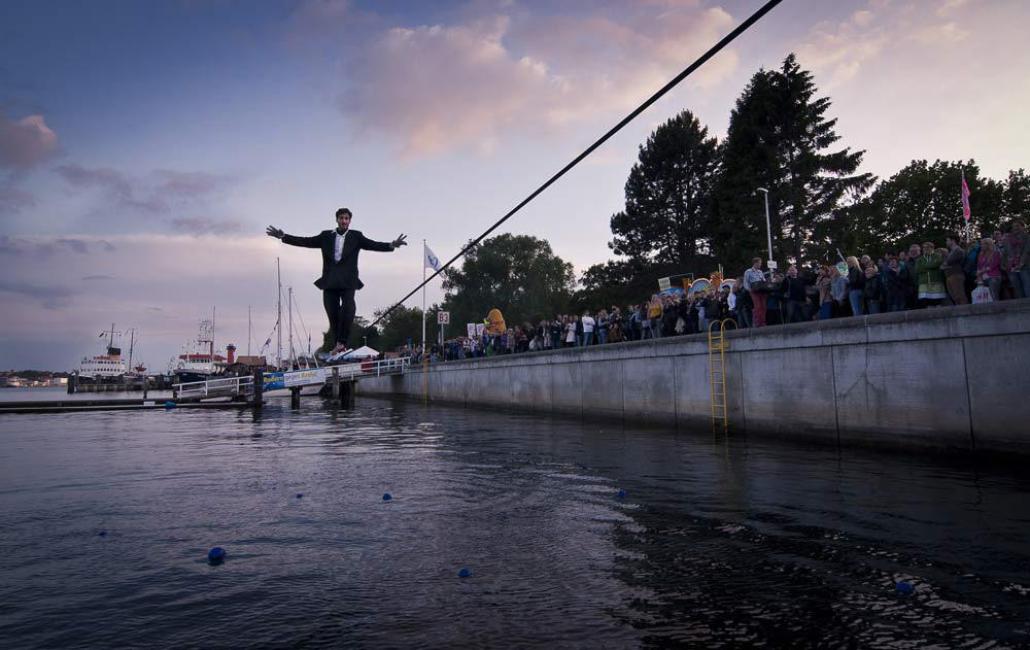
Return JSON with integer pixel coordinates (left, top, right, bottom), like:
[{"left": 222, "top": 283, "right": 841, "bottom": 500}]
[{"left": 355, "top": 54, "right": 1030, "bottom": 349}]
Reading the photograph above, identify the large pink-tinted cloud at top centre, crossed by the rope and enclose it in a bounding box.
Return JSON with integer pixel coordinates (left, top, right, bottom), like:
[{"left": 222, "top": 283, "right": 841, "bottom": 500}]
[{"left": 340, "top": 1, "right": 737, "bottom": 157}]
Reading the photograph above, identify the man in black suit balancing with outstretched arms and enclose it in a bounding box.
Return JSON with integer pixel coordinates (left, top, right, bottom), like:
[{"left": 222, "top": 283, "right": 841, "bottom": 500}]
[{"left": 266, "top": 208, "right": 408, "bottom": 354}]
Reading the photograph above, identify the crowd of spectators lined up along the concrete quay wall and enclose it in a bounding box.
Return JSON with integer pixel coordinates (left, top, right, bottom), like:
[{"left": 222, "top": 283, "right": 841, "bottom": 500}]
[{"left": 408, "top": 220, "right": 1030, "bottom": 361}]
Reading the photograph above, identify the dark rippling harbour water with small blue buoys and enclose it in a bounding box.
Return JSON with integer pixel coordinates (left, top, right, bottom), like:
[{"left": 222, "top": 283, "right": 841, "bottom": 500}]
[{"left": 0, "top": 400, "right": 1030, "bottom": 648}]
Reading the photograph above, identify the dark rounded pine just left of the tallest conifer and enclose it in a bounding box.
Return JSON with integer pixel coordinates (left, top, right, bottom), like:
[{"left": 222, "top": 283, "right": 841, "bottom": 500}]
[{"left": 609, "top": 110, "right": 718, "bottom": 272}]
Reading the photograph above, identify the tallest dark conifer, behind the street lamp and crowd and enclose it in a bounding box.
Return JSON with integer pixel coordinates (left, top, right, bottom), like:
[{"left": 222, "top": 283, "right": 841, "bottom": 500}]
[{"left": 712, "top": 55, "right": 874, "bottom": 270}]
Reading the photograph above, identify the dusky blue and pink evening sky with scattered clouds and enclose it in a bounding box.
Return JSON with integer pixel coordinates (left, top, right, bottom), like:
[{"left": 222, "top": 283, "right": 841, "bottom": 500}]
[{"left": 0, "top": 0, "right": 1030, "bottom": 371}]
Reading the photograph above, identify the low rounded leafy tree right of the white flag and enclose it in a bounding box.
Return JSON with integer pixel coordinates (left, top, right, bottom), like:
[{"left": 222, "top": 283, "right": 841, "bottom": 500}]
[{"left": 443, "top": 234, "right": 575, "bottom": 328}]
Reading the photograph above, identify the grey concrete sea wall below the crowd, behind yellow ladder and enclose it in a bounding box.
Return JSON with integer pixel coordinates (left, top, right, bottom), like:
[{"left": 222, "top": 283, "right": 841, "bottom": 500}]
[{"left": 359, "top": 300, "right": 1030, "bottom": 454}]
